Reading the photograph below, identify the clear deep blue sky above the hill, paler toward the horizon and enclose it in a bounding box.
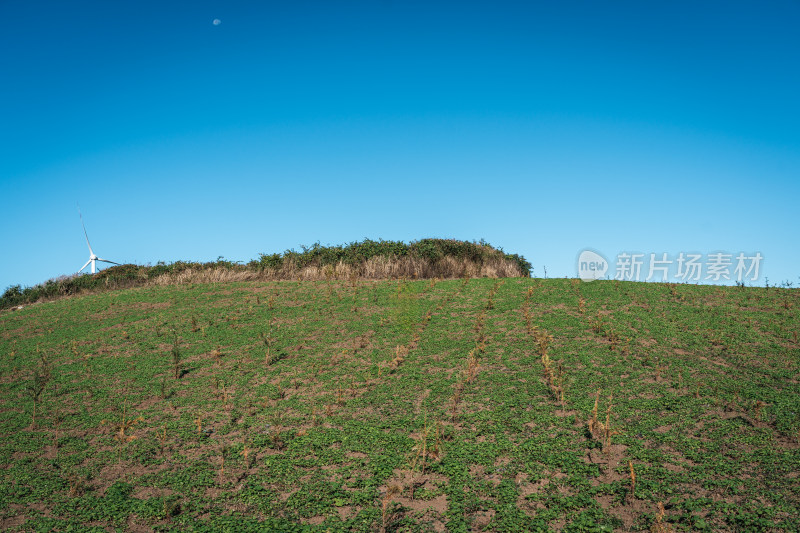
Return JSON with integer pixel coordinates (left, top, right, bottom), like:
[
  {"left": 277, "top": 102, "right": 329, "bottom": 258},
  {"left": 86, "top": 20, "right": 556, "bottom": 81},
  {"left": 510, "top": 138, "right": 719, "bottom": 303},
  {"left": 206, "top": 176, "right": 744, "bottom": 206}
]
[{"left": 0, "top": 0, "right": 800, "bottom": 290}]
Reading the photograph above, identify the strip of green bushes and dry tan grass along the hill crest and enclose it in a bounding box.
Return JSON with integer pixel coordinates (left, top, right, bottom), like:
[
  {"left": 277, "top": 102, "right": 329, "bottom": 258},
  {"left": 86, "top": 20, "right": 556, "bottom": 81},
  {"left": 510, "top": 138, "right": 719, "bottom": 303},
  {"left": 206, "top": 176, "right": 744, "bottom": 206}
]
[{"left": 0, "top": 238, "right": 531, "bottom": 309}]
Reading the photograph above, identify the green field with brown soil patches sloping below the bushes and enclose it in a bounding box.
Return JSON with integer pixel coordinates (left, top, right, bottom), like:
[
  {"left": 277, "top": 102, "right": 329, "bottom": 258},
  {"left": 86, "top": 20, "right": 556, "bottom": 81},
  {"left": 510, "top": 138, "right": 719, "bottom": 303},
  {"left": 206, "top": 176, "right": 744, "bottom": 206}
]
[{"left": 0, "top": 277, "right": 800, "bottom": 531}]
